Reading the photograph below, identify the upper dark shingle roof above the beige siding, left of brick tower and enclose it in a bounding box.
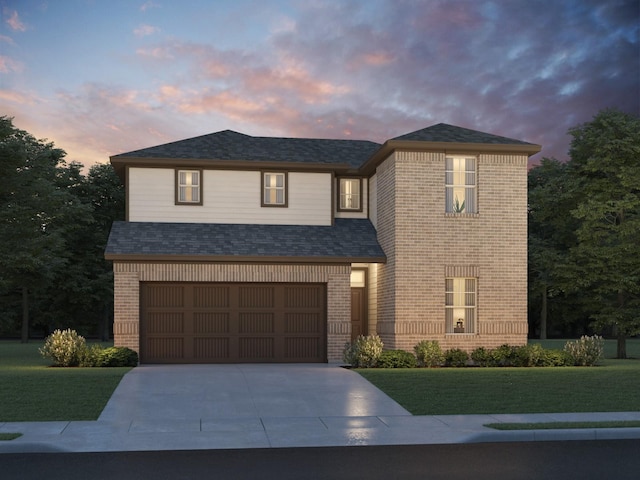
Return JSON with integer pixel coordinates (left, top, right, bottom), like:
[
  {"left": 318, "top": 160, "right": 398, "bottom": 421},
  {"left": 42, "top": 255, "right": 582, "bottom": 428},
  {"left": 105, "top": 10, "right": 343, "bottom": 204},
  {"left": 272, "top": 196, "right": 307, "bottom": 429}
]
[{"left": 112, "top": 130, "right": 380, "bottom": 168}]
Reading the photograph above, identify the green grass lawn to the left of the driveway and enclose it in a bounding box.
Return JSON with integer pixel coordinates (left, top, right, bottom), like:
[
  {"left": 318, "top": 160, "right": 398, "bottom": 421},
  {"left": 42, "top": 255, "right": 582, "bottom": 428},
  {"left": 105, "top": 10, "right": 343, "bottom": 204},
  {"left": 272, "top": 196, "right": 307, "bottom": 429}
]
[{"left": 0, "top": 340, "right": 131, "bottom": 422}]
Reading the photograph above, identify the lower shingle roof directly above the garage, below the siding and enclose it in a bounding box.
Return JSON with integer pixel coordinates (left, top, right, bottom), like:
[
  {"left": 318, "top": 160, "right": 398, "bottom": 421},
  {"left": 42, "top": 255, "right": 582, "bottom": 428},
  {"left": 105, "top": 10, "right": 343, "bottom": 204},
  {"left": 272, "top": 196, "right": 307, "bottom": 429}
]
[{"left": 105, "top": 218, "right": 386, "bottom": 263}]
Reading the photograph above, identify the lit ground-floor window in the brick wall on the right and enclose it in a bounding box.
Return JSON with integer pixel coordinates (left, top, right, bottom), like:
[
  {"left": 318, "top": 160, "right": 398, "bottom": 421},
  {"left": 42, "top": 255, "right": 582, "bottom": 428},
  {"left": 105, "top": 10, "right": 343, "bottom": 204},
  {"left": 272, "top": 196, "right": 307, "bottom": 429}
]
[{"left": 445, "top": 278, "right": 476, "bottom": 333}]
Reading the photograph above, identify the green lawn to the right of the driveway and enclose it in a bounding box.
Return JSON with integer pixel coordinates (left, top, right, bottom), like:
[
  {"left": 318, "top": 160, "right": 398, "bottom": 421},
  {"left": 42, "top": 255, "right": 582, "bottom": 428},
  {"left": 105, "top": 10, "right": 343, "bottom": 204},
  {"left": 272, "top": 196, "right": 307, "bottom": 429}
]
[{"left": 357, "top": 339, "right": 640, "bottom": 415}]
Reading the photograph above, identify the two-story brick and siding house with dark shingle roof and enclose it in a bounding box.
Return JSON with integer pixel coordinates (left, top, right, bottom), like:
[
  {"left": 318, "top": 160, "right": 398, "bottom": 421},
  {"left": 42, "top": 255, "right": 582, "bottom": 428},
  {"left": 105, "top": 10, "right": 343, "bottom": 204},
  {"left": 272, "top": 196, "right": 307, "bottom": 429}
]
[{"left": 105, "top": 124, "right": 540, "bottom": 363}]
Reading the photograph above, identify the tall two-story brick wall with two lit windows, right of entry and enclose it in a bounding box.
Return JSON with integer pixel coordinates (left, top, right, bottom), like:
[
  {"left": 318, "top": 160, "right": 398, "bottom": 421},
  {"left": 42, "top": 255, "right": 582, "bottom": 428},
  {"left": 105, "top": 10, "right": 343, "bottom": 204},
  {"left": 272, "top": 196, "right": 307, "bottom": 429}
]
[{"left": 377, "top": 152, "right": 527, "bottom": 350}]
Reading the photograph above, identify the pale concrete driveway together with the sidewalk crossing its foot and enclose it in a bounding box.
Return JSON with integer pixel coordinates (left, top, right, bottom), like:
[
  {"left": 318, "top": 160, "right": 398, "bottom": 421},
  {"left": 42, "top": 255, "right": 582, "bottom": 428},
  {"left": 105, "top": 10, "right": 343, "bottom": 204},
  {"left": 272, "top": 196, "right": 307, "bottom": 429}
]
[{"left": 0, "top": 364, "right": 640, "bottom": 453}]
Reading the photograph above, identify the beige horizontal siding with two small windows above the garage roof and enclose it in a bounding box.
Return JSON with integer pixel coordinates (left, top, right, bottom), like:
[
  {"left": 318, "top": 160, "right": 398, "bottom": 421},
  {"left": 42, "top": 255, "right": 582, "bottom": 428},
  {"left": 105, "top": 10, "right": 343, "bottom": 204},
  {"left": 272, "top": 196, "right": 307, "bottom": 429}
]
[{"left": 129, "top": 168, "right": 331, "bottom": 225}]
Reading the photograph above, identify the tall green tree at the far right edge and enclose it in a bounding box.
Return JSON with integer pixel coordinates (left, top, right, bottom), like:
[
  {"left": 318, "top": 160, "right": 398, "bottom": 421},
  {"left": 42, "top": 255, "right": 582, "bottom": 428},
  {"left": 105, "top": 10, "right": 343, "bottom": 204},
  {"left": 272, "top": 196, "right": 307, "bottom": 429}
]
[{"left": 568, "top": 110, "right": 640, "bottom": 358}]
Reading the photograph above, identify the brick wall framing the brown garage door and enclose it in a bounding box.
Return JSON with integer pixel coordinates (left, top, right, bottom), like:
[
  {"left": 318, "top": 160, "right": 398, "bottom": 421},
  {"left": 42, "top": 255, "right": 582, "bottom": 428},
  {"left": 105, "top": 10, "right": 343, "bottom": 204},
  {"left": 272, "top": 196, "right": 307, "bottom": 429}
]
[{"left": 113, "top": 262, "right": 351, "bottom": 362}]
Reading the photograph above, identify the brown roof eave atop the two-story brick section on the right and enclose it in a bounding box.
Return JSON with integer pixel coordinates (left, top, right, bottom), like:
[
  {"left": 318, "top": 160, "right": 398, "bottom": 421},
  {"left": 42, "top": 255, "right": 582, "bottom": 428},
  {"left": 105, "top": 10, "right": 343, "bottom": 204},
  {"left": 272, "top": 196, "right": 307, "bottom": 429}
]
[{"left": 360, "top": 140, "right": 542, "bottom": 175}]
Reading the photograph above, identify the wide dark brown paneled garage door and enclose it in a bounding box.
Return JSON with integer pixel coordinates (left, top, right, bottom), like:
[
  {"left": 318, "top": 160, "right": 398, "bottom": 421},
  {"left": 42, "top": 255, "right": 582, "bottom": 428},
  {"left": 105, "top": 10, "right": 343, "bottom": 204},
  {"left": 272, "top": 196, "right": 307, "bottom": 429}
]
[{"left": 140, "top": 282, "right": 327, "bottom": 363}]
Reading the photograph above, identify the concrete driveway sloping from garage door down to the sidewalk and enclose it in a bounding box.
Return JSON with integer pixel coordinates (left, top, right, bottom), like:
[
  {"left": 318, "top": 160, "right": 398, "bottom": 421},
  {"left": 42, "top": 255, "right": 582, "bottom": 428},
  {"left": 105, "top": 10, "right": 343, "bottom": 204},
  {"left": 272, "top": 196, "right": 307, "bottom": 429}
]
[{"left": 100, "top": 364, "right": 410, "bottom": 424}]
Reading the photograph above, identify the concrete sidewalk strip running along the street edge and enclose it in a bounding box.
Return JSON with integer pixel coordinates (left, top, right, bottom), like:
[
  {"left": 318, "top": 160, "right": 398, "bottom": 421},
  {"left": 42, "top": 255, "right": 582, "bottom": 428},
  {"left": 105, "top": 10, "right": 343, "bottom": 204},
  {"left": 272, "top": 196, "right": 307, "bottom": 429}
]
[{"left": 0, "top": 412, "right": 640, "bottom": 453}]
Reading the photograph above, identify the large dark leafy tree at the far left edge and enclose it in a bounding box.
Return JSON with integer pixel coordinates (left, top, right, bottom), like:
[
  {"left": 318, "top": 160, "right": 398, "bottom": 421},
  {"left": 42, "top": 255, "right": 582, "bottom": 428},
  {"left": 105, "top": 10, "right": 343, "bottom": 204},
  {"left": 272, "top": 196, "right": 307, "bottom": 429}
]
[{"left": 0, "top": 117, "right": 87, "bottom": 342}]
